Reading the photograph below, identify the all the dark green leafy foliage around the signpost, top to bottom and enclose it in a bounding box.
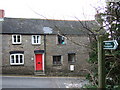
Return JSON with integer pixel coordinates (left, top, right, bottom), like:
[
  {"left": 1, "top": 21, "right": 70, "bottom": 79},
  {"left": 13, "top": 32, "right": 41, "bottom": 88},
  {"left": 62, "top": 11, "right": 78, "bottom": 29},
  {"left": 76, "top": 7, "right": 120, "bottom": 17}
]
[{"left": 86, "top": 1, "right": 120, "bottom": 90}]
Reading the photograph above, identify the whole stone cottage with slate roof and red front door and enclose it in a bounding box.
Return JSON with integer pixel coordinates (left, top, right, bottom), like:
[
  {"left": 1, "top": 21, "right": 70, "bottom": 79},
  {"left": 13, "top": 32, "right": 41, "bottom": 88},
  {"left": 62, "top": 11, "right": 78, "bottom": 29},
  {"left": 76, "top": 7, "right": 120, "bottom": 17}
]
[{"left": 0, "top": 15, "right": 95, "bottom": 75}]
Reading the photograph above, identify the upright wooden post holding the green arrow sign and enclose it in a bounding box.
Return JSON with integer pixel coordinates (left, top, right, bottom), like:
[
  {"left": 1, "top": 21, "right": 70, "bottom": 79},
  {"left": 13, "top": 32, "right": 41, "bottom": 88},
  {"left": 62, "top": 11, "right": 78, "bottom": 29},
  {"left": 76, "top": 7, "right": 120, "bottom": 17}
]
[{"left": 98, "top": 35, "right": 105, "bottom": 90}]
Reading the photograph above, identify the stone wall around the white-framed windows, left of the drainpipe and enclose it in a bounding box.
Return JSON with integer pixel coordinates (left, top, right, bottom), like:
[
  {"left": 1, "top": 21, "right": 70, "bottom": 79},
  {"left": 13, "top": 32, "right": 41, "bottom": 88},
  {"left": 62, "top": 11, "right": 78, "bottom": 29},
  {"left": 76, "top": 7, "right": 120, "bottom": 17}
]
[{"left": 2, "top": 35, "right": 44, "bottom": 74}]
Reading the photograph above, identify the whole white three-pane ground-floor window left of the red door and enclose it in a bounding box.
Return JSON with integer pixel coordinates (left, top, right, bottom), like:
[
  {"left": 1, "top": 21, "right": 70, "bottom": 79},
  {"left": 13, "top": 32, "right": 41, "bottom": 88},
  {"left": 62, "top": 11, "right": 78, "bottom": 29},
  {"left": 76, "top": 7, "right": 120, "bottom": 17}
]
[{"left": 10, "top": 53, "right": 24, "bottom": 65}]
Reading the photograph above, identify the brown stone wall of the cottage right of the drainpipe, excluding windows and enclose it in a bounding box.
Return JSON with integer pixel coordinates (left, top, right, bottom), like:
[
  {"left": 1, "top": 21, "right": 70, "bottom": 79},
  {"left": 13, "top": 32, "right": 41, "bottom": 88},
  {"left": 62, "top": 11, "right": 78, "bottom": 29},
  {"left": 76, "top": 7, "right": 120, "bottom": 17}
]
[{"left": 46, "top": 35, "right": 89, "bottom": 75}]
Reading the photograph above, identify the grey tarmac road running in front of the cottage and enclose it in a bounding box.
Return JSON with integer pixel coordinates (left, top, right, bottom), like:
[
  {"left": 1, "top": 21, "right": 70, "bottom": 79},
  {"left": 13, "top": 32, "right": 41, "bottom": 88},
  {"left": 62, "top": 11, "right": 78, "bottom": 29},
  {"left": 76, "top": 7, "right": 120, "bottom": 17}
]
[{"left": 2, "top": 76, "right": 88, "bottom": 88}]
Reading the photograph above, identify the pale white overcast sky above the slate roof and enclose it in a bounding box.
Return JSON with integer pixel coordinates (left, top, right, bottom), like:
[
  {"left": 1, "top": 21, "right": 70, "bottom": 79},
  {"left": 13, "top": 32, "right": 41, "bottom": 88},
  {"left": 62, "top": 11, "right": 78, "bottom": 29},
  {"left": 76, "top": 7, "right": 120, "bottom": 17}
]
[{"left": 0, "top": 0, "right": 104, "bottom": 20}]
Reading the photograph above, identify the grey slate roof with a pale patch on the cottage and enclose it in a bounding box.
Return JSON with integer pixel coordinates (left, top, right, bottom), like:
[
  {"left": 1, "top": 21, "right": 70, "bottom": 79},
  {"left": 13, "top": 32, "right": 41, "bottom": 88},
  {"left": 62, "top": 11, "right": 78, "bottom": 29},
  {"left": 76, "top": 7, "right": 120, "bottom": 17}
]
[{"left": 2, "top": 18, "right": 95, "bottom": 35}]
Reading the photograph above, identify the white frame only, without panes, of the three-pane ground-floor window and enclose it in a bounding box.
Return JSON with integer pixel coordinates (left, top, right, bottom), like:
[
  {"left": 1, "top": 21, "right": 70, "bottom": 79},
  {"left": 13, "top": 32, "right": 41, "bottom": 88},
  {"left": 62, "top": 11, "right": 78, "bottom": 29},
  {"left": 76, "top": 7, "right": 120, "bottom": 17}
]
[{"left": 10, "top": 53, "right": 24, "bottom": 65}]
